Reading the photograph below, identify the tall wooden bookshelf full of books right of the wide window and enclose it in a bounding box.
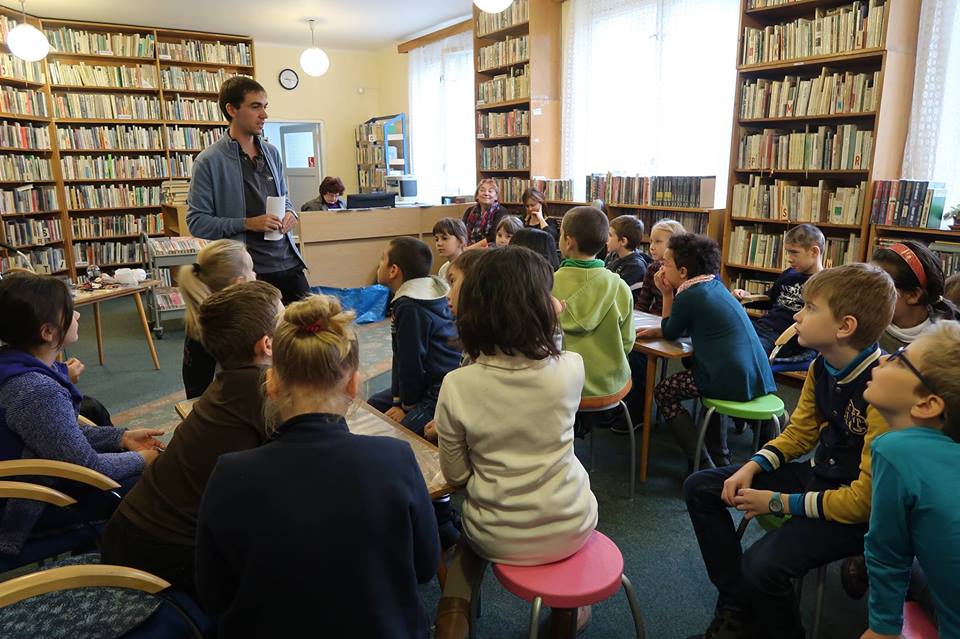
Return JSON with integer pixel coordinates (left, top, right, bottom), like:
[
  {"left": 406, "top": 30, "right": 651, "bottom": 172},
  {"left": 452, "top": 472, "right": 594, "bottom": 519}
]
[{"left": 723, "top": 0, "right": 920, "bottom": 293}]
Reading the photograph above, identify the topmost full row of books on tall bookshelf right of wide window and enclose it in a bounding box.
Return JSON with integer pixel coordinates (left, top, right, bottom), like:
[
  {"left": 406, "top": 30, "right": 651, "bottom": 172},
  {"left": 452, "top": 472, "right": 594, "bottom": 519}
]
[{"left": 740, "top": 0, "right": 886, "bottom": 65}]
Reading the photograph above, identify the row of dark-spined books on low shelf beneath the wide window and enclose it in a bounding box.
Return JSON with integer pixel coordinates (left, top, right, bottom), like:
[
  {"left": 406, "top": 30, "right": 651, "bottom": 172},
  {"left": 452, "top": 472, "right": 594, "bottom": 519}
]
[{"left": 586, "top": 173, "right": 717, "bottom": 208}]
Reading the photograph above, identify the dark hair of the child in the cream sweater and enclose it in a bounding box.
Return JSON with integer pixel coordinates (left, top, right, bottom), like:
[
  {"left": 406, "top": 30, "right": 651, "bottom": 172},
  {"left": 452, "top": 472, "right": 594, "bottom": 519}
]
[{"left": 457, "top": 245, "right": 560, "bottom": 359}]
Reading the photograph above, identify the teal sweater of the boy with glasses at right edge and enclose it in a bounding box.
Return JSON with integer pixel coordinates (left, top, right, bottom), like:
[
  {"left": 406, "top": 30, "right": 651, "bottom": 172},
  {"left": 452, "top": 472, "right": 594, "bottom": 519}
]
[{"left": 864, "top": 426, "right": 960, "bottom": 639}]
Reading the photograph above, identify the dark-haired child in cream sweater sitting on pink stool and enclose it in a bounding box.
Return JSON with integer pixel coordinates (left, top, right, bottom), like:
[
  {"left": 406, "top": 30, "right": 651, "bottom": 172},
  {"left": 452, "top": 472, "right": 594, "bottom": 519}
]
[{"left": 436, "top": 246, "right": 597, "bottom": 639}]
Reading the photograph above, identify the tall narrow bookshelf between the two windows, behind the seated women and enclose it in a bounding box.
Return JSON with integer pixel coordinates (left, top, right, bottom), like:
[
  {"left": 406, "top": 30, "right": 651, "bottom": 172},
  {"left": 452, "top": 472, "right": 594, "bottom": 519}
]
[{"left": 473, "top": 0, "right": 561, "bottom": 181}]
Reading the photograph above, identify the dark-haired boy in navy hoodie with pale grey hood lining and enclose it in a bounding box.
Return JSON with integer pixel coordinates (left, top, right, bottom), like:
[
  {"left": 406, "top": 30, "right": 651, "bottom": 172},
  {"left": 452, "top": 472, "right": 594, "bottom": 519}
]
[{"left": 369, "top": 236, "right": 460, "bottom": 435}]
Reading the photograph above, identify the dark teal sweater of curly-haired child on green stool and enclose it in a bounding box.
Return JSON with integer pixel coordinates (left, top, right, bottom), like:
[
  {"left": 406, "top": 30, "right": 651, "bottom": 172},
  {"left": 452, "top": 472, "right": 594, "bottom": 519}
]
[{"left": 660, "top": 280, "right": 777, "bottom": 402}]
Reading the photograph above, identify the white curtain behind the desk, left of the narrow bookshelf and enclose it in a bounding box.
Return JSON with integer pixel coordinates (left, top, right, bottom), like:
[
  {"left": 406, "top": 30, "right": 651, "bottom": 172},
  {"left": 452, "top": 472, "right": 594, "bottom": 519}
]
[{"left": 408, "top": 31, "right": 477, "bottom": 202}]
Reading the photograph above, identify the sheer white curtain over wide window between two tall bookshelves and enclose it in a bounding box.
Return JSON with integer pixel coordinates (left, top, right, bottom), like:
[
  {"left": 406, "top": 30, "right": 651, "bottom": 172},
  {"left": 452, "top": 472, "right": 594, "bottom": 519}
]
[{"left": 563, "top": 0, "right": 740, "bottom": 204}]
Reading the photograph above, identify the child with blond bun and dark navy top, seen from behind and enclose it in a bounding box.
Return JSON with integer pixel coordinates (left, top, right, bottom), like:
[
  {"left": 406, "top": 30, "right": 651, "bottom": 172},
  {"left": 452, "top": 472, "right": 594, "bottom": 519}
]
[{"left": 197, "top": 295, "right": 440, "bottom": 638}]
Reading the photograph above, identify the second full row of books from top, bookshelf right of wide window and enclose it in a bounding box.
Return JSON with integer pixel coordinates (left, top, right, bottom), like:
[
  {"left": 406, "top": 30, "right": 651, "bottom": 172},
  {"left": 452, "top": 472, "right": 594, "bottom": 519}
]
[{"left": 740, "top": 67, "right": 880, "bottom": 118}]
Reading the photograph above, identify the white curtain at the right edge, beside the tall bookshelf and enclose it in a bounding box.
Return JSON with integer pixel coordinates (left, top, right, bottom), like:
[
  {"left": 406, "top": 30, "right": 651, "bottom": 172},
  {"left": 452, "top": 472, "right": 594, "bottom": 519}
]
[{"left": 903, "top": 0, "right": 960, "bottom": 207}]
